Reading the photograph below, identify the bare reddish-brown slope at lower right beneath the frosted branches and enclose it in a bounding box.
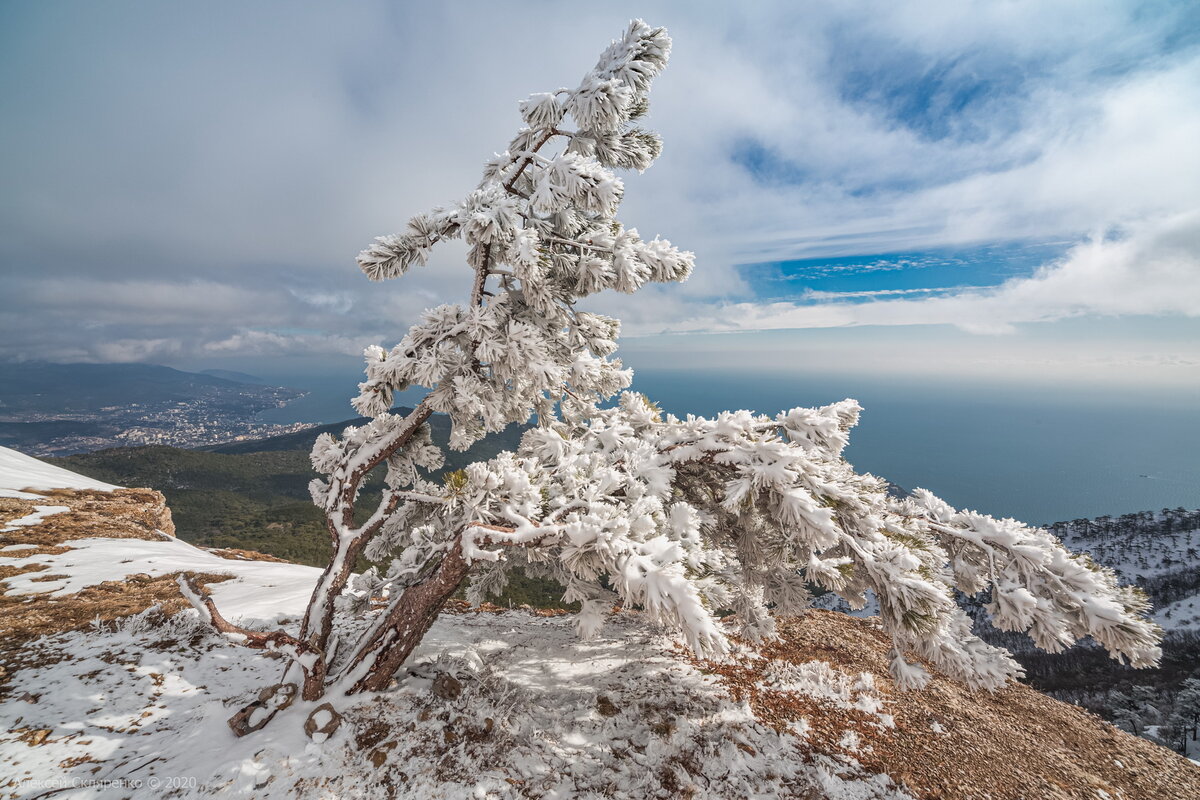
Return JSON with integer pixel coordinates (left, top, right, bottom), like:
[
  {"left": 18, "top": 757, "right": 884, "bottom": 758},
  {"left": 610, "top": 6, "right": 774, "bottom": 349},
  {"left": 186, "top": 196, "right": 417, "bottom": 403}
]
[{"left": 696, "top": 610, "right": 1200, "bottom": 800}]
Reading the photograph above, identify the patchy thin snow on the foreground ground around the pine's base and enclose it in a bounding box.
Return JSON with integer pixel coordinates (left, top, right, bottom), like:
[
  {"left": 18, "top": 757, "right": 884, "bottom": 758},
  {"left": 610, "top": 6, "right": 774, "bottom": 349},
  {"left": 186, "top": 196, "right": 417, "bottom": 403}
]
[{"left": 0, "top": 612, "right": 908, "bottom": 800}]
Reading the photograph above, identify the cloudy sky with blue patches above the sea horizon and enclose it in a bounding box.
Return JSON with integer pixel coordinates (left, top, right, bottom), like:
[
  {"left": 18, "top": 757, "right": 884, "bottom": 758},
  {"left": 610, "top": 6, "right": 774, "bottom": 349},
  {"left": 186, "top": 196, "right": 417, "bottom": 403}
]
[{"left": 0, "top": 0, "right": 1200, "bottom": 390}]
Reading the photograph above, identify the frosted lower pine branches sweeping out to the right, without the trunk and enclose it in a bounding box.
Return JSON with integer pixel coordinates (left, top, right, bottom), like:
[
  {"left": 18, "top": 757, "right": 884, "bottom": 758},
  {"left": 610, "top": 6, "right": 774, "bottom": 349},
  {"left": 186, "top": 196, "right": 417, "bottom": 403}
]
[{"left": 451, "top": 392, "right": 1159, "bottom": 688}]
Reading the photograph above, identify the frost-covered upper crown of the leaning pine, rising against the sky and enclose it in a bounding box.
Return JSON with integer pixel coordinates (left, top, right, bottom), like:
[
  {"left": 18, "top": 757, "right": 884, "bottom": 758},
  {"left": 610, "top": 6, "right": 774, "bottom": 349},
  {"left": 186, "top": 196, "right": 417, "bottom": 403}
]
[{"left": 355, "top": 22, "right": 692, "bottom": 447}]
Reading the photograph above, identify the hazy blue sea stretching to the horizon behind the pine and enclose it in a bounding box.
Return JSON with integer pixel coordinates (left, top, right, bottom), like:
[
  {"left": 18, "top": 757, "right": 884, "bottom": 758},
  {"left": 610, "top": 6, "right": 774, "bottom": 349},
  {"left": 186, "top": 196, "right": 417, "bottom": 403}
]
[{"left": 248, "top": 368, "right": 1200, "bottom": 524}]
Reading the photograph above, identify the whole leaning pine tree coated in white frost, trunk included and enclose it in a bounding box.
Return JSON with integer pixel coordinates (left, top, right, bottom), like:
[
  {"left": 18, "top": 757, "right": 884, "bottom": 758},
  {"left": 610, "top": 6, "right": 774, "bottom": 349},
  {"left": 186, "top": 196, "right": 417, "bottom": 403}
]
[{"left": 177, "top": 20, "right": 1159, "bottom": 733}]
